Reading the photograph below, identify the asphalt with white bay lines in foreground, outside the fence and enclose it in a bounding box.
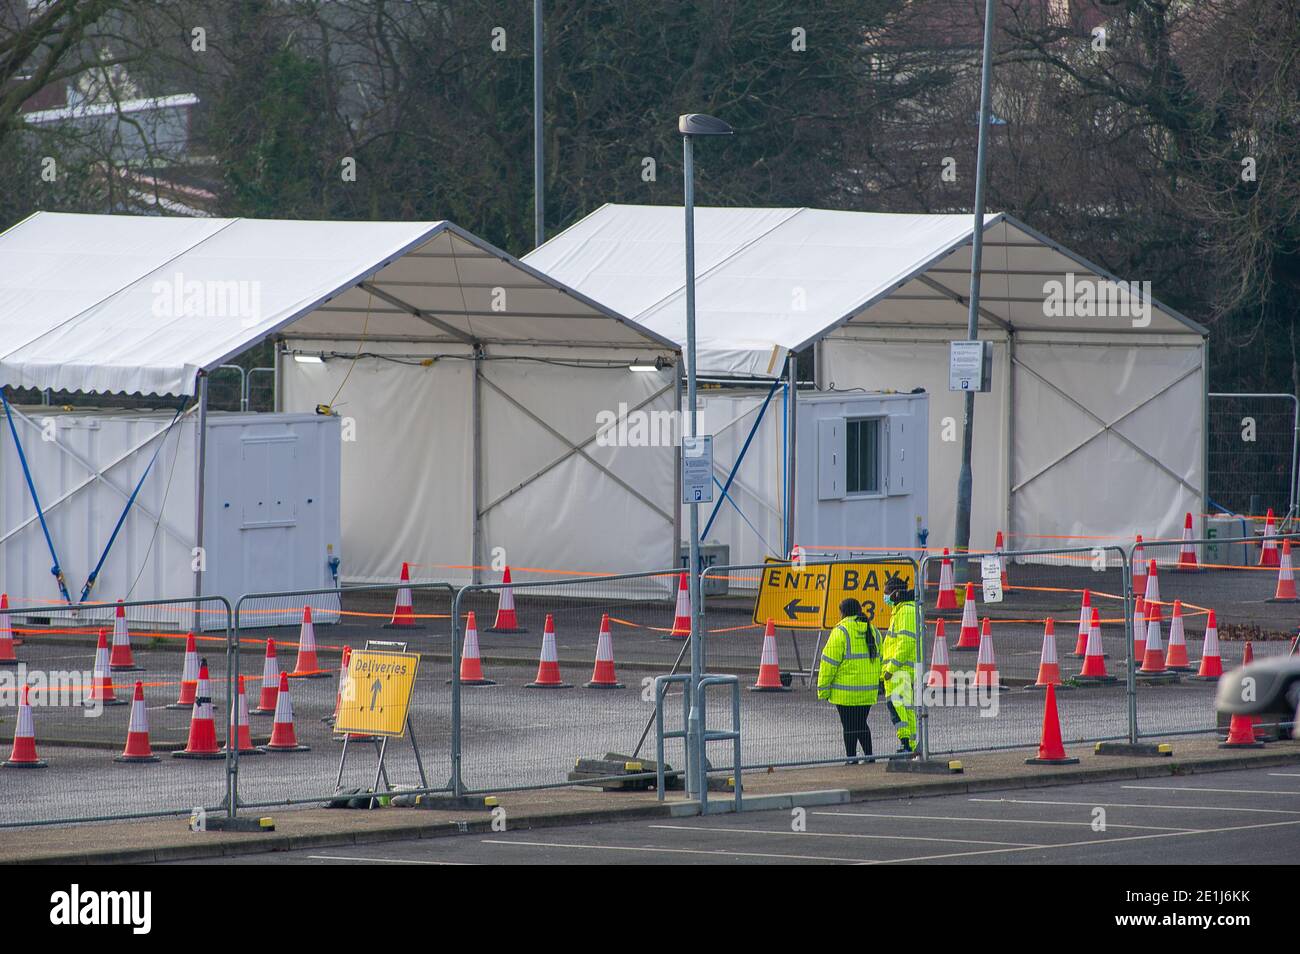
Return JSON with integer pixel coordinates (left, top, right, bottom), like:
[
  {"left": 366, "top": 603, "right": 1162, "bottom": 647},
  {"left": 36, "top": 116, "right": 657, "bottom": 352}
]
[{"left": 170, "top": 767, "right": 1300, "bottom": 866}]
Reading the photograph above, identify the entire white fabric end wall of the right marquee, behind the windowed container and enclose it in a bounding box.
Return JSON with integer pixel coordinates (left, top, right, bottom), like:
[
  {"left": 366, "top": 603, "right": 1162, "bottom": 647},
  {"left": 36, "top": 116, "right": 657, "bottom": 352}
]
[{"left": 819, "top": 325, "right": 1205, "bottom": 551}]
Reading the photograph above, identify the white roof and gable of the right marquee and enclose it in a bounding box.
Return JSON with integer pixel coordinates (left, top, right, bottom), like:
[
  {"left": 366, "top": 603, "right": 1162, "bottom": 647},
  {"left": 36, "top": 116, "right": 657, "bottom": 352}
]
[{"left": 524, "top": 204, "right": 1206, "bottom": 374}]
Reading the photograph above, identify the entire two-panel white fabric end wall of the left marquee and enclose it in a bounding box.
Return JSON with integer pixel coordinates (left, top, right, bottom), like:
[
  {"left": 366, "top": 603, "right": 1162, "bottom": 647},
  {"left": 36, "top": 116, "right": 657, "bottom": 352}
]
[{"left": 281, "top": 339, "right": 677, "bottom": 582}]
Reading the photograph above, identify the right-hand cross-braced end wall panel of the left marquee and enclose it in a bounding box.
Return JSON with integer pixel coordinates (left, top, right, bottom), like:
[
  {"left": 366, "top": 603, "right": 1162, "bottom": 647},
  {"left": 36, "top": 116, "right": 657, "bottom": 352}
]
[{"left": 482, "top": 347, "right": 679, "bottom": 580}]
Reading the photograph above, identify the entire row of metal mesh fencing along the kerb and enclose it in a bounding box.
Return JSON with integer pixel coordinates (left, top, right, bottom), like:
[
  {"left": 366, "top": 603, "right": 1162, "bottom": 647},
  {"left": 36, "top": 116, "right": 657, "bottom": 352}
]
[{"left": 0, "top": 534, "right": 1300, "bottom": 827}]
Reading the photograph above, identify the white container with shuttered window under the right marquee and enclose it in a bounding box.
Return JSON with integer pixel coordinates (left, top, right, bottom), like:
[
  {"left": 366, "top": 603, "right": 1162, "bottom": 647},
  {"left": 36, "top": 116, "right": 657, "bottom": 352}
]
[{"left": 683, "top": 390, "right": 930, "bottom": 574}]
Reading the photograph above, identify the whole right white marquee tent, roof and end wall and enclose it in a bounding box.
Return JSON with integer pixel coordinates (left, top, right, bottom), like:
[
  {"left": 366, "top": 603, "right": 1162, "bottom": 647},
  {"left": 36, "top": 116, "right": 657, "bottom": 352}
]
[{"left": 525, "top": 205, "right": 1208, "bottom": 550}]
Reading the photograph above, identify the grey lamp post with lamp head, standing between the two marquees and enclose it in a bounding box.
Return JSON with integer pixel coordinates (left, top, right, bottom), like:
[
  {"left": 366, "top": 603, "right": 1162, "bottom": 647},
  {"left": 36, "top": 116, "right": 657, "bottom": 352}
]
[{"left": 677, "top": 113, "right": 733, "bottom": 798}]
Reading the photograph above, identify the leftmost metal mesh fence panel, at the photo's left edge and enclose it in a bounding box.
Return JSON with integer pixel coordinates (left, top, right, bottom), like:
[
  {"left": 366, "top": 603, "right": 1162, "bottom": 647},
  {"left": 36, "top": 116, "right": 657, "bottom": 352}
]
[{"left": 0, "top": 597, "right": 233, "bottom": 828}]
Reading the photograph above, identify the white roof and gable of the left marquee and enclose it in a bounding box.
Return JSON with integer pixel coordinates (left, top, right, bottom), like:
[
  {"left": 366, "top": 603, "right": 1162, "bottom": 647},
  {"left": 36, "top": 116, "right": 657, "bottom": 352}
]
[{"left": 0, "top": 212, "right": 676, "bottom": 394}]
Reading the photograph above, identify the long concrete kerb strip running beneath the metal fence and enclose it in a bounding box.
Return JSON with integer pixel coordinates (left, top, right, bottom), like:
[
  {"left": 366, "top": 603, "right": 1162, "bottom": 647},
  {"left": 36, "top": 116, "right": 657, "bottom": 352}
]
[{"left": 0, "top": 741, "right": 1300, "bottom": 864}]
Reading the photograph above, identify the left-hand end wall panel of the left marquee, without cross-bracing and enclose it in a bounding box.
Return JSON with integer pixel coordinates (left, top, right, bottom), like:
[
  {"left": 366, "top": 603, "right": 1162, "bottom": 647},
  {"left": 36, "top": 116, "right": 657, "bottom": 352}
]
[{"left": 281, "top": 341, "right": 473, "bottom": 582}]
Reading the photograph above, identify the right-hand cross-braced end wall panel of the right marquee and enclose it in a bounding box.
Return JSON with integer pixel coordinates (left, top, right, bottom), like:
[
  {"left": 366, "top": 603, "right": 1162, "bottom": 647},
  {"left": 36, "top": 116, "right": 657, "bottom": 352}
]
[{"left": 1011, "top": 338, "right": 1205, "bottom": 546}]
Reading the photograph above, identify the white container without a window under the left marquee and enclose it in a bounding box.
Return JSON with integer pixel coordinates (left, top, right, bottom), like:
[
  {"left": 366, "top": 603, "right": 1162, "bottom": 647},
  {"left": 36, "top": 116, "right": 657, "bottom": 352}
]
[{"left": 0, "top": 407, "right": 339, "bottom": 629}]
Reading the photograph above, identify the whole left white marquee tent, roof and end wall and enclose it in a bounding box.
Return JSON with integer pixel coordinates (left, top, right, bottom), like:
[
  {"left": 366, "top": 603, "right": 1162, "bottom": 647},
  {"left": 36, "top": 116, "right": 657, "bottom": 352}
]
[{"left": 0, "top": 213, "right": 677, "bottom": 598}]
